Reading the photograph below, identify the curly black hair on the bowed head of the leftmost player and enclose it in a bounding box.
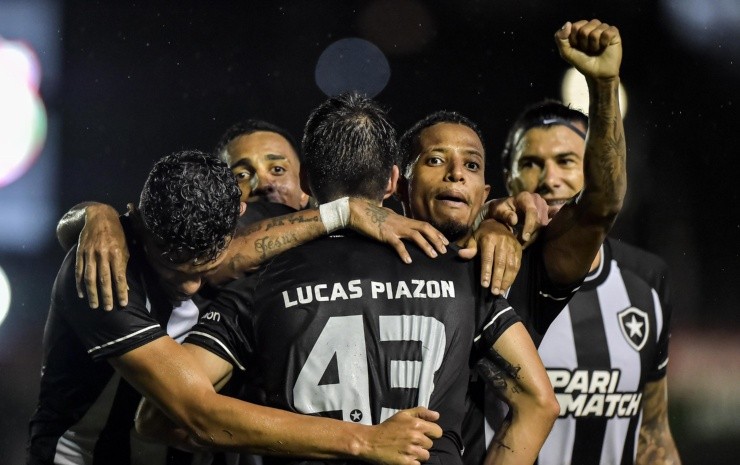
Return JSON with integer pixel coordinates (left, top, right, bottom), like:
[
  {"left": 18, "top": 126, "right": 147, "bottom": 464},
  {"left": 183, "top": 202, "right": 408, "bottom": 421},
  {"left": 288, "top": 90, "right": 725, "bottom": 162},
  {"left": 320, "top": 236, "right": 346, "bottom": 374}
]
[{"left": 139, "top": 150, "right": 240, "bottom": 264}]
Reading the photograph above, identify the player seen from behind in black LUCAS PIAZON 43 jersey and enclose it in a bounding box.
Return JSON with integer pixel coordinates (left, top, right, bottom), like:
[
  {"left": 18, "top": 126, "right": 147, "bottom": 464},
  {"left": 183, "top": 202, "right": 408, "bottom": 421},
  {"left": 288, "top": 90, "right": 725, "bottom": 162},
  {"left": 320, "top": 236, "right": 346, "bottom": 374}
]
[{"left": 138, "top": 94, "right": 557, "bottom": 463}]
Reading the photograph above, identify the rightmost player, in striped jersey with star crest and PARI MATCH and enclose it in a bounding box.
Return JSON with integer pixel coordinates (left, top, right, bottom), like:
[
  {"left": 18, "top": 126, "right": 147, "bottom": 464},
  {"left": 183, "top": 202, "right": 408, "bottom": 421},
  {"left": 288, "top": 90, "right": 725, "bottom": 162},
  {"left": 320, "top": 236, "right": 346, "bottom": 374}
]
[{"left": 502, "top": 101, "right": 680, "bottom": 465}]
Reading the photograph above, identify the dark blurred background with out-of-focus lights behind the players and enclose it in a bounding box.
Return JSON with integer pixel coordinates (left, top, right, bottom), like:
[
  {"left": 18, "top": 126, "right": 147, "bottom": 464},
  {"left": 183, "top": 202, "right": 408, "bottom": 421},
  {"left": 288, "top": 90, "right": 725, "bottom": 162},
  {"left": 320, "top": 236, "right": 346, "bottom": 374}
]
[{"left": 0, "top": 0, "right": 740, "bottom": 465}]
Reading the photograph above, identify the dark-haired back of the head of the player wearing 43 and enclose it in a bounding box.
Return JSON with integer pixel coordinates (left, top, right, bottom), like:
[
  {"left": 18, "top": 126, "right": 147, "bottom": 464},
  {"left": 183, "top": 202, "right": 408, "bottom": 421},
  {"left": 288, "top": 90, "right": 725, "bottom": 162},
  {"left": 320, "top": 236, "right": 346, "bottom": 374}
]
[{"left": 303, "top": 92, "right": 398, "bottom": 203}]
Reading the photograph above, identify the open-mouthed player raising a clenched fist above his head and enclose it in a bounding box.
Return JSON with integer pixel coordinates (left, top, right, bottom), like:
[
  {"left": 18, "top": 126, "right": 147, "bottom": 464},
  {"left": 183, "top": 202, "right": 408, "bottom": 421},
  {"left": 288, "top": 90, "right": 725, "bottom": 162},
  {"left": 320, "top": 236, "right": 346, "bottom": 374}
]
[{"left": 401, "top": 20, "right": 626, "bottom": 464}]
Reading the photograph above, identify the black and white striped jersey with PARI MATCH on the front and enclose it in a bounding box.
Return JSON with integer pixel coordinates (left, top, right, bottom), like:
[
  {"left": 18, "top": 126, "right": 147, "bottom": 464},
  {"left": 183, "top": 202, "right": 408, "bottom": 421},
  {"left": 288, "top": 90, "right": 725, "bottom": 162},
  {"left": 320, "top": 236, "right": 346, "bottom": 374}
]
[{"left": 538, "top": 239, "right": 671, "bottom": 465}]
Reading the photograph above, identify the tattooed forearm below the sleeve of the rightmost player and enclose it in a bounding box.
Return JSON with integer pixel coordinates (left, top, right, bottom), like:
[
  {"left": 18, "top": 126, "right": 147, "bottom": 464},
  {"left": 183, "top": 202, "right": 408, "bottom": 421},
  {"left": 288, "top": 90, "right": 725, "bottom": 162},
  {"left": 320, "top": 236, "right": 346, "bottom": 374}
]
[{"left": 635, "top": 377, "right": 681, "bottom": 465}]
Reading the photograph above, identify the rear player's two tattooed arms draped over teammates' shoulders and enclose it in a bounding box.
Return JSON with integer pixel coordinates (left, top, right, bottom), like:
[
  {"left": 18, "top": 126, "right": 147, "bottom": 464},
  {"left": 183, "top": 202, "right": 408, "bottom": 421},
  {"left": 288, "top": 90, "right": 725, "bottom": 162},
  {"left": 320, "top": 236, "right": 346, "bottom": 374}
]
[{"left": 57, "top": 198, "right": 448, "bottom": 310}]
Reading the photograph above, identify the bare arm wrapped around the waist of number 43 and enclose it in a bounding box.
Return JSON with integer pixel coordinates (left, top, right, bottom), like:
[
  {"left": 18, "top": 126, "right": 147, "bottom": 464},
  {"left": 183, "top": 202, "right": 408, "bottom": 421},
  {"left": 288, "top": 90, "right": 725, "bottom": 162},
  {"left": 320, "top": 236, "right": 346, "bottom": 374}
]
[{"left": 121, "top": 337, "right": 442, "bottom": 465}]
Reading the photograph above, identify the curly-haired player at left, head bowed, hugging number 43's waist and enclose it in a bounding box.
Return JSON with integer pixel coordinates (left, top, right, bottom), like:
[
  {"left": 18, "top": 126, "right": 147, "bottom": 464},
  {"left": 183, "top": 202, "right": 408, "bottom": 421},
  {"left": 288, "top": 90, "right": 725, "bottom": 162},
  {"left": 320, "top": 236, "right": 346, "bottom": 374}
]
[{"left": 27, "top": 151, "right": 441, "bottom": 465}]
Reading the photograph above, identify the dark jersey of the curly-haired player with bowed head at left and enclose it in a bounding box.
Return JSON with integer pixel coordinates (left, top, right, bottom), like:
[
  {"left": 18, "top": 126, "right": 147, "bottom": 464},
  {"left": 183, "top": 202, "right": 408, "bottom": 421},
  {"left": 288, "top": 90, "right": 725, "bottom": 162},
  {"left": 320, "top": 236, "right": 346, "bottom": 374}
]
[{"left": 27, "top": 219, "right": 214, "bottom": 465}]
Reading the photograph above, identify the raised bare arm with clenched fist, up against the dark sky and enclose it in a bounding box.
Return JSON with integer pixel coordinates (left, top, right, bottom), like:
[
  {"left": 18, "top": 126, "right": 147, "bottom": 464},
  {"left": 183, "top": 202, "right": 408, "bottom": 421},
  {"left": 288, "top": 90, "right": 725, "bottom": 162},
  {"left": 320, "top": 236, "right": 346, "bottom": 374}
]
[{"left": 544, "top": 20, "right": 627, "bottom": 283}]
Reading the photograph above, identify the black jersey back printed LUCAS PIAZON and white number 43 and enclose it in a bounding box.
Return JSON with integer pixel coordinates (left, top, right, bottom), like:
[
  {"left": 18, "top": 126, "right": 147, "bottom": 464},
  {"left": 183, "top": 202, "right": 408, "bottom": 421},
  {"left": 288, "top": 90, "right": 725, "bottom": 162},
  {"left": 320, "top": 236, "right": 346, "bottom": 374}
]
[{"left": 186, "top": 231, "right": 520, "bottom": 464}]
